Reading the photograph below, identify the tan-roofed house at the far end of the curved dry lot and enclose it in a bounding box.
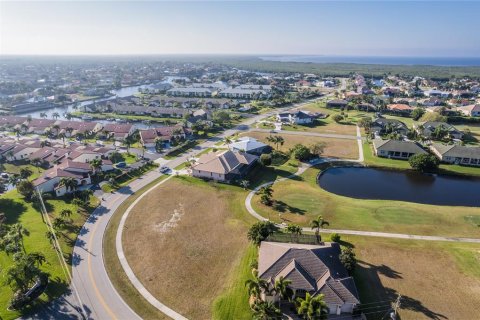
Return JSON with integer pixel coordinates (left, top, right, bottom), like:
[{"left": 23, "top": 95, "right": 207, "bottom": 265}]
[{"left": 192, "top": 150, "right": 258, "bottom": 182}]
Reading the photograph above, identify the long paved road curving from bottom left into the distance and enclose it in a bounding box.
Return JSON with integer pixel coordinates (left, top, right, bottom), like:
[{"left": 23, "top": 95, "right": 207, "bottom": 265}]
[{"left": 22, "top": 99, "right": 322, "bottom": 320}]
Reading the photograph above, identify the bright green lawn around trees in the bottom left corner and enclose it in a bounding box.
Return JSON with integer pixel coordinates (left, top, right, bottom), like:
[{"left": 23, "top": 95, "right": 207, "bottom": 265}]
[{"left": 0, "top": 190, "right": 97, "bottom": 319}]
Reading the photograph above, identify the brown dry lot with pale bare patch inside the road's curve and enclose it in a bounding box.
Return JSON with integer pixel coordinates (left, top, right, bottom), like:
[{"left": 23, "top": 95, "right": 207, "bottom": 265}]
[{"left": 123, "top": 178, "right": 248, "bottom": 319}]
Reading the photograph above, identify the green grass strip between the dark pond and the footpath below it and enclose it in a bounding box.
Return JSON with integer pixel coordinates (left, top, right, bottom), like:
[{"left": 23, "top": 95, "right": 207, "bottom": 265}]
[{"left": 252, "top": 168, "right": 480, "bottom": 237}]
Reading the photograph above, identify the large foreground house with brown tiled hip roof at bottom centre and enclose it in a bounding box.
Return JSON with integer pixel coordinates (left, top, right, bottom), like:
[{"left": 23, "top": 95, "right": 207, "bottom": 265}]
[{"left": 258, "top": 241, "right": 360, "bottom": 315}]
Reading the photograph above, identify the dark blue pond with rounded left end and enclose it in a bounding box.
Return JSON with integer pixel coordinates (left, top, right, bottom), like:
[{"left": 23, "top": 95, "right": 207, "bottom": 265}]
[{"left": 317, "top": 167, "right": 480, "bottom": 207}]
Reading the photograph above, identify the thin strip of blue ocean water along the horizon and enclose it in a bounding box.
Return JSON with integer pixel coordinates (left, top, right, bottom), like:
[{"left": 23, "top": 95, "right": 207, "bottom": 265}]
[{"left": 260, "top": 55, "right": 480, "bottom": 67}]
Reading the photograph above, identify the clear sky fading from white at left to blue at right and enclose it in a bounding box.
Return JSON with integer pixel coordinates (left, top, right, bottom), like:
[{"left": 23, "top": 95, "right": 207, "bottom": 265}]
[{"left": 0, "top": 0, "right": 480, "bottom": 57}]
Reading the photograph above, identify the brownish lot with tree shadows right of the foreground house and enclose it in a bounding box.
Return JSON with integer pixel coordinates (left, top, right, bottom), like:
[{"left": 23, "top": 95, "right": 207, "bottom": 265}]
[{"left": 342, "top": 236, "right": 480, "bottom": 320}]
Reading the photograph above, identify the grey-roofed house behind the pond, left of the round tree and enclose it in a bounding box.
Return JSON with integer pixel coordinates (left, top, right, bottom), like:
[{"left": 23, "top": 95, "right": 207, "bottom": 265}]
[{"left": 373, "top": 138, "right": 427, "bottom": 160}]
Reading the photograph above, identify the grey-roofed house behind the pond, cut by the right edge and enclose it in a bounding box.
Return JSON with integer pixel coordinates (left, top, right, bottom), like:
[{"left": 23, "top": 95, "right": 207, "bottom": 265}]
[{"left": 430, "top": 143, "right": 480, "bottom": 166}]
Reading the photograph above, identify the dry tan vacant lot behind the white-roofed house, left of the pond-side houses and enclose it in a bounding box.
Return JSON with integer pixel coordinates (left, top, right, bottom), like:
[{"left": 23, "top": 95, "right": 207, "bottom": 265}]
[{"left": 241, "top": 132, "right": 358, "bottom": 159}]
